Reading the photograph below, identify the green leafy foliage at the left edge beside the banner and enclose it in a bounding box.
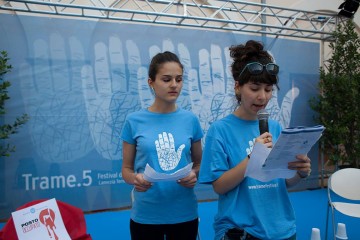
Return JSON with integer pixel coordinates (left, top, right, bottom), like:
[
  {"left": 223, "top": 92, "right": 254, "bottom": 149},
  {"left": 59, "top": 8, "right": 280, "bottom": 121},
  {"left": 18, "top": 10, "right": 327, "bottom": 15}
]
[{"left": 0, "top": 51, "right": 29, "bottom": 157}]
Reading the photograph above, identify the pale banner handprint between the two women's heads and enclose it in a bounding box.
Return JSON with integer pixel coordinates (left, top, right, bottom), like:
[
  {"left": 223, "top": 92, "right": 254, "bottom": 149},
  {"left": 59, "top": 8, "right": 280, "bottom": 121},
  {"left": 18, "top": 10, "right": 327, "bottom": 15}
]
[{"left": 178, "top": 44, "right": 235, "bottom": 136}]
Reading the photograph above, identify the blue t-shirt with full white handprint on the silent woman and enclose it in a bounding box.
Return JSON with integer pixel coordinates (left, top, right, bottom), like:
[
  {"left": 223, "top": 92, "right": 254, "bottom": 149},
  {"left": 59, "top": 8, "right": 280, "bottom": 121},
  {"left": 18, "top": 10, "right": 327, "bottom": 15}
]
[{"left": 121, "top": 109, "right": 203, "bottom": 224}]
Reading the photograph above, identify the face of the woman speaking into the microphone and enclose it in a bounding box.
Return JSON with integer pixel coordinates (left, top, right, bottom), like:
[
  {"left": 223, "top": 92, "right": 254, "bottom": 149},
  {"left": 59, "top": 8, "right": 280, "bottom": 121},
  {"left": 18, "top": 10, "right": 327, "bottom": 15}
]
[{"left": 235, "top": 82, "right": 273, "bottom": 119}]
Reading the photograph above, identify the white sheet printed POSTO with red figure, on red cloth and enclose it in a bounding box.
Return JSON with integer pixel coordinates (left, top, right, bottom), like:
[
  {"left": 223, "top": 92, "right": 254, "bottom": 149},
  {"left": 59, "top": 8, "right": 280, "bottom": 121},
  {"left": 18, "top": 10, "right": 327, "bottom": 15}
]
[{"left": 12, "top": 198, "right": 71, "bottom": 240}]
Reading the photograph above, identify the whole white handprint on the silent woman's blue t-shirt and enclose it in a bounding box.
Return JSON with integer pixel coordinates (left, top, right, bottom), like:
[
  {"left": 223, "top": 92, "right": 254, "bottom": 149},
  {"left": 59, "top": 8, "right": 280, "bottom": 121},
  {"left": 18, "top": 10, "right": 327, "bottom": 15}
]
[{"left": 155, "top": 132, "right": 185, "bottom": 171}]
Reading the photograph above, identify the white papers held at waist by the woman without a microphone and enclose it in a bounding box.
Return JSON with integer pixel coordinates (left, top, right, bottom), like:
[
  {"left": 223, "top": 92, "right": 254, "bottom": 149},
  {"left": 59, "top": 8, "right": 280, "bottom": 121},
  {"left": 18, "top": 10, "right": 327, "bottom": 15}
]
[{"left": 144, "top": 163, "right": 193, "bottom": 182}]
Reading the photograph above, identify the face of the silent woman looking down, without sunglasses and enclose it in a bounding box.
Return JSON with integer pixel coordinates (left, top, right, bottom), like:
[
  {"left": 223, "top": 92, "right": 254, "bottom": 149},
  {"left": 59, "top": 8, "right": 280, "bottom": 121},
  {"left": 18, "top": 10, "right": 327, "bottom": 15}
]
[{"left": 149, "top": 62, "right": 183, "bottom": 103}]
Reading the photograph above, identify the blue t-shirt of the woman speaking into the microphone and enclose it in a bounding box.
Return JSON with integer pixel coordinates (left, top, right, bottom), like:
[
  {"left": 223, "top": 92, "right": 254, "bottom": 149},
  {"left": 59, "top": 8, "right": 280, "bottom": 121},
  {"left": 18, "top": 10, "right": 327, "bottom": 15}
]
[{"left": 199, "top": 114, "right": 296, "bottom": 240}]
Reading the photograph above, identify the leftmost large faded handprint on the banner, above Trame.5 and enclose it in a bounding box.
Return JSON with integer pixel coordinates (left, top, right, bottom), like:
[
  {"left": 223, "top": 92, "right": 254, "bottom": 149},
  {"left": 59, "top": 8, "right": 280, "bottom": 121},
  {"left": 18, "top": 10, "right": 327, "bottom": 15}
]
[{"left": 19, "top": 31, "right": 93, "bottom": 162}]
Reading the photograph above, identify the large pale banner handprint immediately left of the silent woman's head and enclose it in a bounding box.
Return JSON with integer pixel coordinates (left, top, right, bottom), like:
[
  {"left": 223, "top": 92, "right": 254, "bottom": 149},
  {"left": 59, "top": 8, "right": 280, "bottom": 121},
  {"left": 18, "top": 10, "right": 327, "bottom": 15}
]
[{"left": 81, "top": 36, "right": 152, "bottom": 160}]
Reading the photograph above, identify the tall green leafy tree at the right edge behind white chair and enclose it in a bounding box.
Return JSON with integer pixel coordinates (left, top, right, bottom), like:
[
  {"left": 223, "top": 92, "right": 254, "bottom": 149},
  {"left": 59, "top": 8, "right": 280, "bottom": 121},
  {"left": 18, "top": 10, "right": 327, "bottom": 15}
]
[{"left": 310, "top": 19, "right": 360, "bottom": 168}]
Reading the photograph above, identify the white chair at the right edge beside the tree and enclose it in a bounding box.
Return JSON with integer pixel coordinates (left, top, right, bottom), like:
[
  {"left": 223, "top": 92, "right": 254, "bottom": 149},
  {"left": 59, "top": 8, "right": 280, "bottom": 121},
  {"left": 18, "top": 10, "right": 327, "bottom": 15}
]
[{"left": 325, "top": 168, "right": 360, "bottom": 240}]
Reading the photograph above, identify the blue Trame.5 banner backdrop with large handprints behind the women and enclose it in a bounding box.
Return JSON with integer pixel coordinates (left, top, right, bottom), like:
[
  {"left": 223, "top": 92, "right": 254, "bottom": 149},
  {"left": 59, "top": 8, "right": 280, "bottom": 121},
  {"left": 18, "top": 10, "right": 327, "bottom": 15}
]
[{"left": 0, "top": 14, "right": 319, "bottom": 219}]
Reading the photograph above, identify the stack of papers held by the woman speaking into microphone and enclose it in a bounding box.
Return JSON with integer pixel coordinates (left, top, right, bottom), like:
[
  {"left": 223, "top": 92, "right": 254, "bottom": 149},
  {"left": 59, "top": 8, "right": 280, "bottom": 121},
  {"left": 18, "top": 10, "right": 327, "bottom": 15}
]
[{"left": 245, "top": 125, "right": 325, "bottom": 182}]
